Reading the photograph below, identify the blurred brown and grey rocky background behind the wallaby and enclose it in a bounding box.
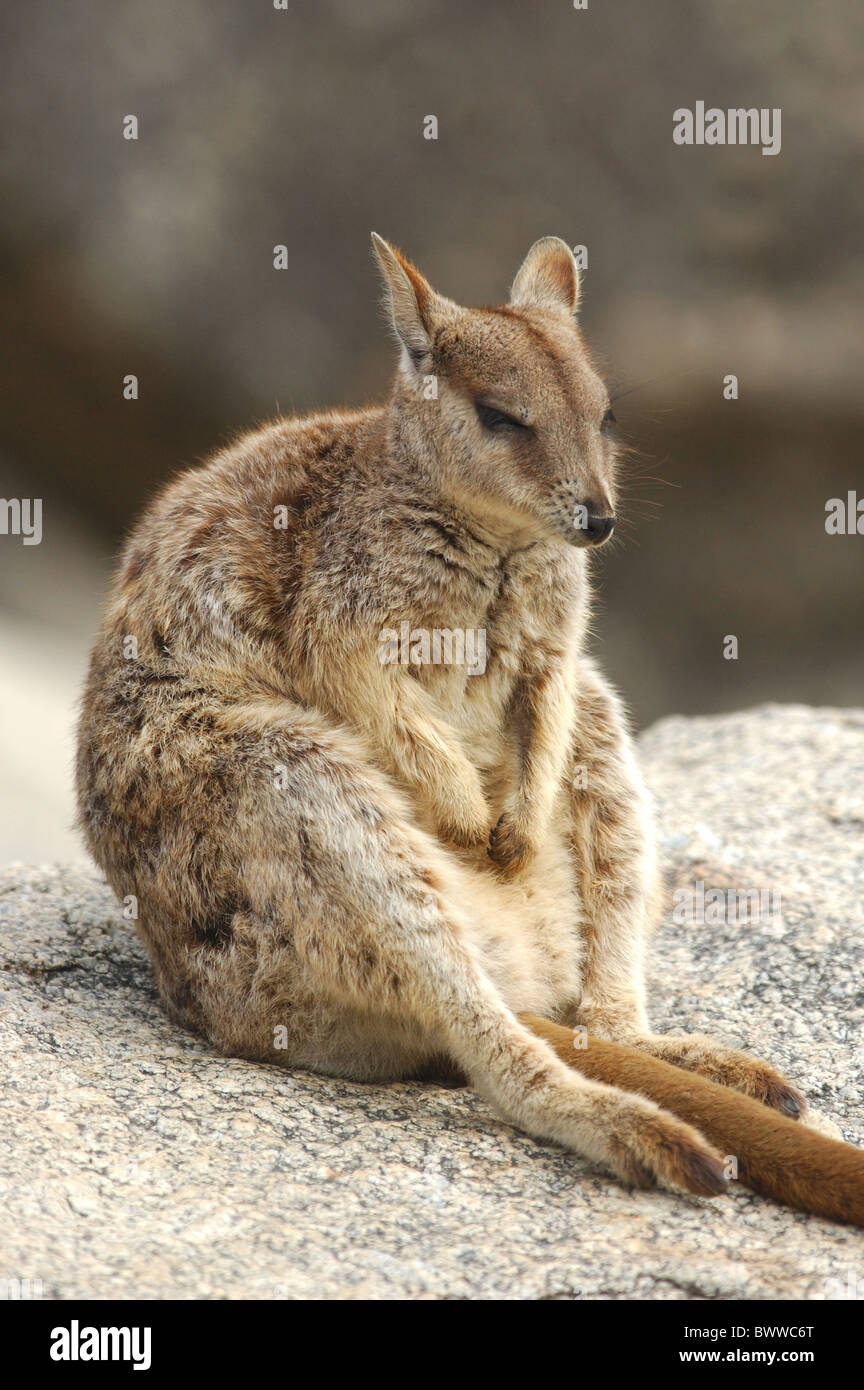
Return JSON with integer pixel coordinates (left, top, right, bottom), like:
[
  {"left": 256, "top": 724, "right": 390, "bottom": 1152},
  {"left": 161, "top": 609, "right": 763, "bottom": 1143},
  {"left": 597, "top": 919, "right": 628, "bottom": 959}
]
[{"left": 0, "top": 0, "right": 864, "bottom": 860}]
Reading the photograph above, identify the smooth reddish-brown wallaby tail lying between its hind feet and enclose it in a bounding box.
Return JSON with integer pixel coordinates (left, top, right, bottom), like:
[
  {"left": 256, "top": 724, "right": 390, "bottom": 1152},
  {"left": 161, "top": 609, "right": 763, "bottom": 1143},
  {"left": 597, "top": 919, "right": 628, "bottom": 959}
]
[{"left": 521, "top": 1015, "right": 864, "bottom": 1226}]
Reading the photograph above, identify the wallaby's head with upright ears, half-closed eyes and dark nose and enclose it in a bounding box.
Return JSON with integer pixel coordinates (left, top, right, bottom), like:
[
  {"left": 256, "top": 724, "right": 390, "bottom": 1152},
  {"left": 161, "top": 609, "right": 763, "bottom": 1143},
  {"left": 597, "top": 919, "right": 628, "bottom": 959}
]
[{"left": 372, "top": 234, "right": 615, "bottom": 546}]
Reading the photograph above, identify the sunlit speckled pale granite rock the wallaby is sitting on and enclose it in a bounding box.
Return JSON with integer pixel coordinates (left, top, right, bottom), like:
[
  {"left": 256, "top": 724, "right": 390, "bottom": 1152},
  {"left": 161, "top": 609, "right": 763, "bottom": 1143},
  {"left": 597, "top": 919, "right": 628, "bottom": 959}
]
[{"left": 0, "top": 706, "right": 864, "bottom": 1300}]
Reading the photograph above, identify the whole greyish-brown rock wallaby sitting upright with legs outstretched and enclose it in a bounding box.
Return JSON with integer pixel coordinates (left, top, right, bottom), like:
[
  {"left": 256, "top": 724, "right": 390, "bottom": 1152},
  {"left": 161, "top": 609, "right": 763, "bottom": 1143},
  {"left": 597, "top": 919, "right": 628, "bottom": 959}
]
[{"left": 78, "top": 236, "right": 864, "bottom": 1223}]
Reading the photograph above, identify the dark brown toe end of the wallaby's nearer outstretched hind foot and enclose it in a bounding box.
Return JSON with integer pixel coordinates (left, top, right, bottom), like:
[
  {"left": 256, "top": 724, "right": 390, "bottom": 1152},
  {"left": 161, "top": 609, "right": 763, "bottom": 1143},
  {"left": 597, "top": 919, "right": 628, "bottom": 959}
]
[{"left": 608, "top": 1102, "right": 726, "bottom": 1197}]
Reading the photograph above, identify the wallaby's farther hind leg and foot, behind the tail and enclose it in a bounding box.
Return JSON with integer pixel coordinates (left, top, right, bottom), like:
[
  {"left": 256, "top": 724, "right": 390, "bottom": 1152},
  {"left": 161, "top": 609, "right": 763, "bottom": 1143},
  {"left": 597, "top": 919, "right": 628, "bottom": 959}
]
[{"left": 567, "top": 670, "right": 806, "bottom": 1118}]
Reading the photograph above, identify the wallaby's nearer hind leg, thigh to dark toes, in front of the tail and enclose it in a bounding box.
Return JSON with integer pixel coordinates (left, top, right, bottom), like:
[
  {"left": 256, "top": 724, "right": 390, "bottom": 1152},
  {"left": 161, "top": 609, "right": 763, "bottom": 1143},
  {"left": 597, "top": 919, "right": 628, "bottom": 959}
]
[{"left": 148, "top": 720, "right": 724, "bottom": 1195}]
